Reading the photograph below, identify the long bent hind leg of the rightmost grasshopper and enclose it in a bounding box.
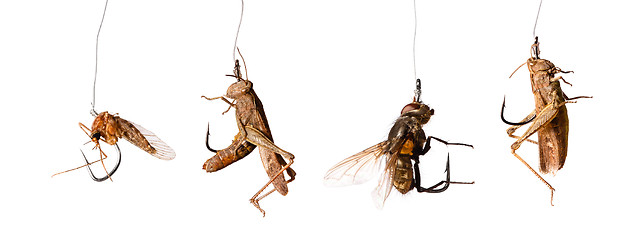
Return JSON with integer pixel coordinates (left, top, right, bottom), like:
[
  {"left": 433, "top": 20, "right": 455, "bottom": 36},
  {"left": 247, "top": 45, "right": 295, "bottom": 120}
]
[{"left": 507, "top": 101, "right": 566, "bottom": 206}]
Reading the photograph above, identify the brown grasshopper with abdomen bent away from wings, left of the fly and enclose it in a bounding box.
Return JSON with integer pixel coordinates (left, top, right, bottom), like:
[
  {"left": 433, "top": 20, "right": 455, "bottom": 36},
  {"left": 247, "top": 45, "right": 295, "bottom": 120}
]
[{"left": 202, "top": 60, "right": 296, "bottom": 217}]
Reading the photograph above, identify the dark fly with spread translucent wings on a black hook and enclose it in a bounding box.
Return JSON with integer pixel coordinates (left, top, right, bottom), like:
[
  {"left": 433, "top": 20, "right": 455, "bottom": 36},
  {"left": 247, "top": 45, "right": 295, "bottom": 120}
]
[{"left": 324, "top": 87, "right": 474, "bottom": 208}]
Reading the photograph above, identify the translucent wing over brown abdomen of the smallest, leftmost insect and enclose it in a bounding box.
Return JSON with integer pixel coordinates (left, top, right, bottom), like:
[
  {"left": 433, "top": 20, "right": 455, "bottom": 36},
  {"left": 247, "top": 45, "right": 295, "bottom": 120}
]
[{"left": 116, "top": 117, "right": 176, "bottom": 160}]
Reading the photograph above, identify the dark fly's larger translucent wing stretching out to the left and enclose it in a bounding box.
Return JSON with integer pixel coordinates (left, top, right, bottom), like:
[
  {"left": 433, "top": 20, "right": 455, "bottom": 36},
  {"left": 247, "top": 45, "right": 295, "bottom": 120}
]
[{"left": 325, "top": 141, "right": 386, "bottom": 186}]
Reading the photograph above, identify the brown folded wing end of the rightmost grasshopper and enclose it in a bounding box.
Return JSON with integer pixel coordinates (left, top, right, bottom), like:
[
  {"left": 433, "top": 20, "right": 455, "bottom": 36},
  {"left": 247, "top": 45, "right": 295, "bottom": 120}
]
[{"left": 538, "top": 106, "right": 568, "bottom": 174}]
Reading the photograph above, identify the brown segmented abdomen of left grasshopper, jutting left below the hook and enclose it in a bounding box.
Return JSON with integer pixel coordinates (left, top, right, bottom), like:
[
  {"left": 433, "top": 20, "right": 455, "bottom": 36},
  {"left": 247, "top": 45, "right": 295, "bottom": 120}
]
[{"left": 202, "top": 141, "right": 257, "bottom": 172}]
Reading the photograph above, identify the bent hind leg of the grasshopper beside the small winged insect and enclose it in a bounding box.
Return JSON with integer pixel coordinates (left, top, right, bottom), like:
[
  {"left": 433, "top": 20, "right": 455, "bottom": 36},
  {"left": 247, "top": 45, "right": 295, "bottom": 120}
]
[{"left": 238, "top": 122, "right": 296, "bottom": 217}]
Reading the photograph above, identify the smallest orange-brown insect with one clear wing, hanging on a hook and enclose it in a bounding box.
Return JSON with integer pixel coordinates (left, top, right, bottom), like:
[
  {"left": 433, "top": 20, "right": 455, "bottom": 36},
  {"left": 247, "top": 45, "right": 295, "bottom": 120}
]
[{"left": 53, "top": 112, "right": 176, "bottom": 182}]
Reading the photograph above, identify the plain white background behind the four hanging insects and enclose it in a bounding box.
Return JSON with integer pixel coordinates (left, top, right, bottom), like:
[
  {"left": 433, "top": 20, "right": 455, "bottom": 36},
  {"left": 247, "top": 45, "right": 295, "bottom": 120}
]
[{"left": 0, "top": 0, "right": 632, "bottom": 239}]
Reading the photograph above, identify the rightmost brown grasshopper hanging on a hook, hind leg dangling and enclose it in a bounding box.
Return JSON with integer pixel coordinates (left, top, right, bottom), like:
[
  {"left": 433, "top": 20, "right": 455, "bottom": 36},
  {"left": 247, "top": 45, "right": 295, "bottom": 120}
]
[{"left": 500, "top": 37, "right": 592, "bottom": 205}]
